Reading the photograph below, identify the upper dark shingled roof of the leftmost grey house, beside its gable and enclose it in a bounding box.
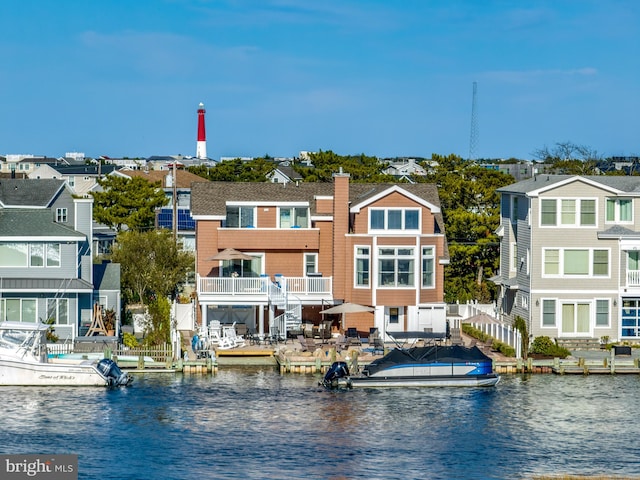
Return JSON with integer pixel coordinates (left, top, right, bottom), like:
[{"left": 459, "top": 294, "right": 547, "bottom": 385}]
[{"left": 0, "top": 178, "right": 64, "bottom": 207}]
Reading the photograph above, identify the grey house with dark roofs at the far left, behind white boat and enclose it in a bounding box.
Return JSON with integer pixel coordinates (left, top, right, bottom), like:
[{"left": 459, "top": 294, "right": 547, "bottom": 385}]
[{"left": 0, "top": 179, "right": 120, "bottom": 341}]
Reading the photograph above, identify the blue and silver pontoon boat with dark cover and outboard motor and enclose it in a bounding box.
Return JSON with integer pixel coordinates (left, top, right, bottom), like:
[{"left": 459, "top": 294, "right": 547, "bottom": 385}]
[{"left": 321, "top": 332, "right": 500, "bottom": 389}]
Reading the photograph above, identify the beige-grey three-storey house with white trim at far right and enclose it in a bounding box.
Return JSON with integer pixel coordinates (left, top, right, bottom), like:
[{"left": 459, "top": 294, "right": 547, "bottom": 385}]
[{"left": 494, "top": 174, "right": 640, "bottom": 341}]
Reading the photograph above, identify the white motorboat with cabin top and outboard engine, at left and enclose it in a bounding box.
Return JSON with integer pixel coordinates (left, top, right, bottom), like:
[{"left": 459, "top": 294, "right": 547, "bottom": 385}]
[{"left": 0, "top": 322, "right": 132, "bottom": 387}]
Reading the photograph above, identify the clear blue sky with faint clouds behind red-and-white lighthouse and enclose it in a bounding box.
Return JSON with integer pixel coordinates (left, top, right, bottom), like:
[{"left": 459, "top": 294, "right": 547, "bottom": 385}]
[{"left": 0, "top": 0, "right": 640, "bottom": 159}]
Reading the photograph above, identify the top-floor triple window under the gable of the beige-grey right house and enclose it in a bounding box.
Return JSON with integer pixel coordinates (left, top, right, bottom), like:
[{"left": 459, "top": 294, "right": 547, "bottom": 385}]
[{"left": 540, "top": 198, "right": 596, "bottom": 227}]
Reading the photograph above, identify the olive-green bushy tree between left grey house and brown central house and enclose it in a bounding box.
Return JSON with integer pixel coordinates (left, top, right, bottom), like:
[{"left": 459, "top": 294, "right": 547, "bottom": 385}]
[{"left": 111, "top": 230, "right": 195, "bottom": 341}]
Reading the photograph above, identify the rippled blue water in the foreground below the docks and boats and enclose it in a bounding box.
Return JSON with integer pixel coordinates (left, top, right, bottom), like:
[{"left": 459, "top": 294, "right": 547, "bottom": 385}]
[{"left": 0, "top": 367, "right": 640, "bottom": 480}]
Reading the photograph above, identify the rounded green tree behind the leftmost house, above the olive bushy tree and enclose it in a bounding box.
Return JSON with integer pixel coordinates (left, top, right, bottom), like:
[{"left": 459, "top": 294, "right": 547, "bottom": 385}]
[{"left": 91, "top": 175, "right": 169, "bottom": 232}]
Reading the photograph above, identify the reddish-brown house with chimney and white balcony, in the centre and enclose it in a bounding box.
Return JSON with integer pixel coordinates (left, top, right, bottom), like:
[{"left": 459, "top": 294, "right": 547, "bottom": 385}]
[{"left": 191, "top": 173, "right": 448, "bottom": 340}]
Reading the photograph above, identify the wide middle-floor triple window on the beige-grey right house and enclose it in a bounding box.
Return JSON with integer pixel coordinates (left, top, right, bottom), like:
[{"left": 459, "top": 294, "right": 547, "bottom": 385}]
[{"left": 543, "top": 248, "right": 609, "bottom": 277}]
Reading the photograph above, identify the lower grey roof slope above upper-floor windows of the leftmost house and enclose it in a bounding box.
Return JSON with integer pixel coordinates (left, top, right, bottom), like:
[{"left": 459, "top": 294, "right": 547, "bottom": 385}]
[{"left": 0, "top": 208, "right": 86, "bottom": 240}]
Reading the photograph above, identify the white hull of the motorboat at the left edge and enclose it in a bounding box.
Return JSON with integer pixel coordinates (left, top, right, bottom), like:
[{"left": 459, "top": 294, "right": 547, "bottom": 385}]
[{"left": 0, "top": 359, "right": 110, "bottom": 387}]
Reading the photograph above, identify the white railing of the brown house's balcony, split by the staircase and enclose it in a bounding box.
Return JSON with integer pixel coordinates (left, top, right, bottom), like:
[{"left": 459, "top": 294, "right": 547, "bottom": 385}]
[{"left": 198, "top": 275, "right": 333, "bottom": 301}]
